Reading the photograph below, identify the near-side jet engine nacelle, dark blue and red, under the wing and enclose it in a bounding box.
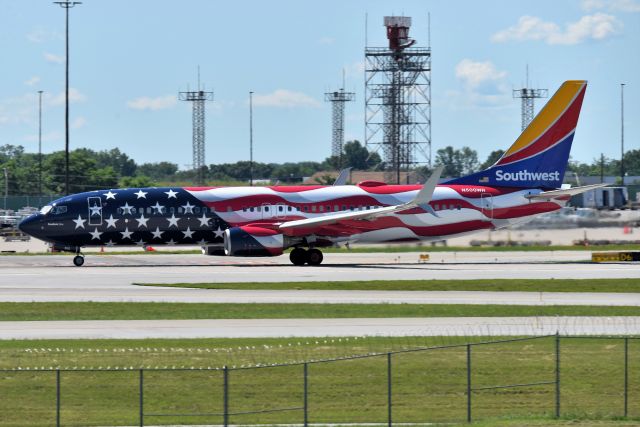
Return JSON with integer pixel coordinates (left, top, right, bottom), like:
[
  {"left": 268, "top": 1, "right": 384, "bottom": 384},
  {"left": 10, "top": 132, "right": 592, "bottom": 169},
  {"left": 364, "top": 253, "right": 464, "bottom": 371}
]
[{"left": 224, "top": 225, "right": 284, "bottom": 257}]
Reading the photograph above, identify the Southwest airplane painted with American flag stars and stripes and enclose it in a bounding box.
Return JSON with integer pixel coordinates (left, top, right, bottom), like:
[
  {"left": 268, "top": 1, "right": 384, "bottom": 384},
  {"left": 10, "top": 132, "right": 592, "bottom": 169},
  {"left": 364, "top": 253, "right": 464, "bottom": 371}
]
[{"left": 19, "top": 80, "right": 602, "bottom": 266}]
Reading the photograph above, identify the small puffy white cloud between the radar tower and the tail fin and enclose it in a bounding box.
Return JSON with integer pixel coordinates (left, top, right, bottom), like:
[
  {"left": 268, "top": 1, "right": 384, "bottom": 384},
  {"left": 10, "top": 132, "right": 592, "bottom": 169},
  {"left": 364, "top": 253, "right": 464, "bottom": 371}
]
[{"left": 447, "top": 59, "right": 511, "bottom": 108}]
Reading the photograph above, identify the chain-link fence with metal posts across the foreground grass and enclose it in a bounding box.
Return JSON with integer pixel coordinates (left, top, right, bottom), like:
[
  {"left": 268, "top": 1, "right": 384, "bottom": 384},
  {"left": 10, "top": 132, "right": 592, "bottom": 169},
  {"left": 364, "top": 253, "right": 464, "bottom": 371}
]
[{"left": 0, "top": 334, "right": 640, "bottom": 426}]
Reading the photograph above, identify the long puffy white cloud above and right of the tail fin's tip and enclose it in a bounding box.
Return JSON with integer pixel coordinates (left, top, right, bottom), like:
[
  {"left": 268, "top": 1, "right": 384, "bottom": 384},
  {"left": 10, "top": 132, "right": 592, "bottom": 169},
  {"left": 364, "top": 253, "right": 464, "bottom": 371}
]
[{"left": 491, "top": 13, "right": 623, "bottom": 45}]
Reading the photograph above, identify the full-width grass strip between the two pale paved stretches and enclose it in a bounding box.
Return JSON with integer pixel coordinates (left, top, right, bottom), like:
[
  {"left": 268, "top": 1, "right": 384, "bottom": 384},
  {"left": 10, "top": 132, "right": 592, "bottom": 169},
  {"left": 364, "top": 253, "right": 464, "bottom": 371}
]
[{"left": 0, "top": 302, "right": 640, "bottom": 320}]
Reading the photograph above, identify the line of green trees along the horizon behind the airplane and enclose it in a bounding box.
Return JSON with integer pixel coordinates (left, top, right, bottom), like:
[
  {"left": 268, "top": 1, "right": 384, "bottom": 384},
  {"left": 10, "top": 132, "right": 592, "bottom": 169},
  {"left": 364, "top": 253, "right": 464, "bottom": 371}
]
[{"left": 0, "top": 141, "right": 640, "bottom": 195}]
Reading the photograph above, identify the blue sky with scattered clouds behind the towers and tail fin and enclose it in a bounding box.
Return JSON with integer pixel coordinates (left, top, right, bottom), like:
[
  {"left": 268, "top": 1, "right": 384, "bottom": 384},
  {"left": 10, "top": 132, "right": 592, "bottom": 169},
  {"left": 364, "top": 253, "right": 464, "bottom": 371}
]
[{"left": 0, "top": 0, "right": 640, "bottom": 168}]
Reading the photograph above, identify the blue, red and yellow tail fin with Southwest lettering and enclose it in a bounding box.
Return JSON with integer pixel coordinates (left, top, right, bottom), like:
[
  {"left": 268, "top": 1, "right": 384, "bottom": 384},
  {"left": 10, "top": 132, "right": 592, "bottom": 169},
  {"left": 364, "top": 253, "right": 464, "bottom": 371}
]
[{"left": 447, "top": 80, "right": 587, "bottom": 189}]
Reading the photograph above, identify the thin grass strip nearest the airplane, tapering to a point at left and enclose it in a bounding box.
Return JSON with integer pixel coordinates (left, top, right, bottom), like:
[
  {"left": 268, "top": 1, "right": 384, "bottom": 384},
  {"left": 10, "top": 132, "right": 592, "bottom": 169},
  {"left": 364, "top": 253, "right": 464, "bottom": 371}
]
[{"left": 136, "top": 279, "right": 640, "bottom": 292}]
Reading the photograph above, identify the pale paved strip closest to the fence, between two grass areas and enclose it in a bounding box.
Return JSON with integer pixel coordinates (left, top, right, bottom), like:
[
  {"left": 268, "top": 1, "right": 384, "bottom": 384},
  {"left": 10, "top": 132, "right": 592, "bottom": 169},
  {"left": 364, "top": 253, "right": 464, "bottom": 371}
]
[{"left": 0, "top": 317, "right": 640, "bottom": 340}]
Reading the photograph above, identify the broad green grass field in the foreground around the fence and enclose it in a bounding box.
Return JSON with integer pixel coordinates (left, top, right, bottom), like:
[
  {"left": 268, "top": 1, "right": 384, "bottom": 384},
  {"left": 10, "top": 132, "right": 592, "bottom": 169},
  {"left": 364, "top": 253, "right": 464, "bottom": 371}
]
[{"left": 0, "top": 337, "right": 640, "bottom": 427}]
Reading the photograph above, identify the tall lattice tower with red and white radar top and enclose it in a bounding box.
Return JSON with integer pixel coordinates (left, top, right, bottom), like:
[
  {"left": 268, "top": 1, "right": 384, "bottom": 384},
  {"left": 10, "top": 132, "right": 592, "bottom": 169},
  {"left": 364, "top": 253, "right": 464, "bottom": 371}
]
[{"left": 365, "top": 16, "right": 431, "bottom": 184}]
